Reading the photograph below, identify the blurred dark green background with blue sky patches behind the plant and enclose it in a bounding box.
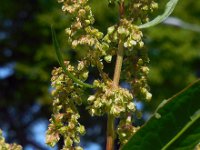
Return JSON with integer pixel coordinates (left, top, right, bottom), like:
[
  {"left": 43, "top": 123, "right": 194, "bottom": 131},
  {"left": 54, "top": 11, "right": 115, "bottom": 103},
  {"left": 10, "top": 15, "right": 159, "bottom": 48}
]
[{"left": 0, "top": 0, "right": 200, "bottom": 150}]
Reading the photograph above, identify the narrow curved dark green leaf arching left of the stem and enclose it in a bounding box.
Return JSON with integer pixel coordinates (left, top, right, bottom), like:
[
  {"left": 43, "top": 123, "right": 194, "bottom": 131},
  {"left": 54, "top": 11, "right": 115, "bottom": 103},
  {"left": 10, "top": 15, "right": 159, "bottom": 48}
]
[{"left": 51, "top": 26, "right": 94, "bottom": 88}]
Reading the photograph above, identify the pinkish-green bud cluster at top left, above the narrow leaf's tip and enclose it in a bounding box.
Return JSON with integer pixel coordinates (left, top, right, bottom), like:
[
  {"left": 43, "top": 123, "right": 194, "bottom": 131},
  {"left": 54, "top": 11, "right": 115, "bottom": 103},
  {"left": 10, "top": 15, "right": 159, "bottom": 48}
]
[{"left": 59, "top": 0, "right": 103, "bottom": 49}]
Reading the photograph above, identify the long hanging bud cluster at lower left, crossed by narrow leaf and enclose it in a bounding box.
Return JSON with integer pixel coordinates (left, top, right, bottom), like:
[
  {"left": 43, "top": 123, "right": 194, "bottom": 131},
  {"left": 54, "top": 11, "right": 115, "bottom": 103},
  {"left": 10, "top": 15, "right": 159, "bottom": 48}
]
[{"left": 46, "top": 61, "right": 88, "bottom": 150}]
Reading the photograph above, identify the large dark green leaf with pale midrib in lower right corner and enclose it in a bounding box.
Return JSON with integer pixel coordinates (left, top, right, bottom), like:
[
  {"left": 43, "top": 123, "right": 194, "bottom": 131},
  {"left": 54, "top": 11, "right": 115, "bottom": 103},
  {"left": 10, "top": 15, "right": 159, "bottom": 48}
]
[{"left": 122, "top": 80, "right": 200, "bottom": 150}]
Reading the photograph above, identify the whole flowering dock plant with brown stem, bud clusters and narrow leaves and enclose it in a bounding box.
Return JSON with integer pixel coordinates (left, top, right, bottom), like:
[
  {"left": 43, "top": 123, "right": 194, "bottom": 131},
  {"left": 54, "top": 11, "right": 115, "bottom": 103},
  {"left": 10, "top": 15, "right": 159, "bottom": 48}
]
[{"left": 46, "top": 0, "right": 177, "bottom": 150}]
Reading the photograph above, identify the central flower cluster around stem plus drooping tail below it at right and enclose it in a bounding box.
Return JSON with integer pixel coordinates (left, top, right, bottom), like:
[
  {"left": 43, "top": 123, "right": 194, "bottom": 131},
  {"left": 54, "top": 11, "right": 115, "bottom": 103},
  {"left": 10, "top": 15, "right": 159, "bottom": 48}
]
[{"left": 87, "top": 80, "right": 138, "bottom": 146}]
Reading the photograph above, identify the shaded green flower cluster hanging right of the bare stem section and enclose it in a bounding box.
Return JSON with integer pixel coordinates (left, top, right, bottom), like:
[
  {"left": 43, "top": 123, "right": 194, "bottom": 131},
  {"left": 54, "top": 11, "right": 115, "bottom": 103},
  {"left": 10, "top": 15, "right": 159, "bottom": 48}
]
[{"left": 122, "top": 47, "right": 152, "bottom": 101}]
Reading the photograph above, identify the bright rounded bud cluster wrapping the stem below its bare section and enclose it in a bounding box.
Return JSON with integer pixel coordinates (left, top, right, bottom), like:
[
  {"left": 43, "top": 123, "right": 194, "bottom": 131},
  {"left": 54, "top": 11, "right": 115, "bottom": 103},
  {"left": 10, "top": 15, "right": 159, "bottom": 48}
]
[{"left": 88, "top": 80, "right": 136, "bottom": 118}]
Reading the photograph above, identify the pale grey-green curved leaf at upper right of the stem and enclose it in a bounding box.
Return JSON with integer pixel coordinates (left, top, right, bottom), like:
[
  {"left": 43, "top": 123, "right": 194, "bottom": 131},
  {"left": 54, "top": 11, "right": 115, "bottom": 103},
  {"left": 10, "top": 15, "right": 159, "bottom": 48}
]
[{"left": 138, "top": 0, "right": 178, "bottom": 29}]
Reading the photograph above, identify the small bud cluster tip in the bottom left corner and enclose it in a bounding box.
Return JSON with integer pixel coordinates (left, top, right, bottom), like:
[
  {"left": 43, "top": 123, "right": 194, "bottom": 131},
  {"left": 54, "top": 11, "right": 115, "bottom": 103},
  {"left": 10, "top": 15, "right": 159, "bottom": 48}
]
[{"left": 0, "top": 130, "right": 22, "bottom": 150}]
